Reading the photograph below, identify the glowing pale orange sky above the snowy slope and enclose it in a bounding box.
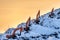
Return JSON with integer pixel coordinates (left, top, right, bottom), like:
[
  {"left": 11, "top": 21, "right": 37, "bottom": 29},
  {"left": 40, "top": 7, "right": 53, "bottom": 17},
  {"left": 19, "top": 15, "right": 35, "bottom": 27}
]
[{"left": 0, "top": 0, "right": 60, "bottom": 33}]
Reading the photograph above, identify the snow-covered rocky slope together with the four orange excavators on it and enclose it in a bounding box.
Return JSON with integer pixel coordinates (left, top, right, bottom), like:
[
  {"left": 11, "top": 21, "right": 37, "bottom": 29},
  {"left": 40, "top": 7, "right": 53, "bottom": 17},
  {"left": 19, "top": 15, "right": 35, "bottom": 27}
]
[{"left": 0, "top": 8, "right": 60, "bottom": 40}]
